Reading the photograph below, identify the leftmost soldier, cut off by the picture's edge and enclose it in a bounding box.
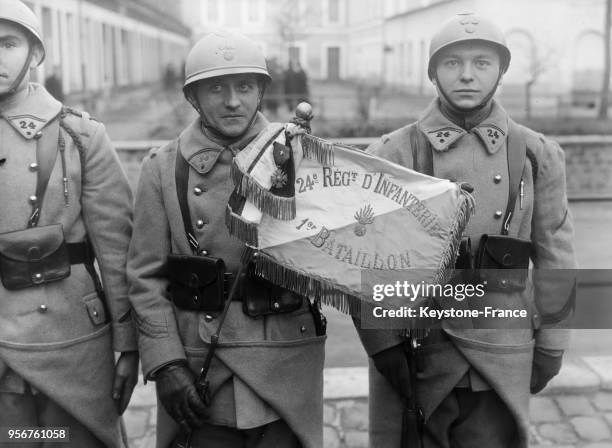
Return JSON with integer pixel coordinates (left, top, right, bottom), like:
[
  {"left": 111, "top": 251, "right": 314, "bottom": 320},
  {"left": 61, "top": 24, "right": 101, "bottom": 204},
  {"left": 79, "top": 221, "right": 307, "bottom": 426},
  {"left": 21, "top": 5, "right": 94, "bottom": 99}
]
[{"left": 0, "top": 0, "right": 138, "bottom": 448}]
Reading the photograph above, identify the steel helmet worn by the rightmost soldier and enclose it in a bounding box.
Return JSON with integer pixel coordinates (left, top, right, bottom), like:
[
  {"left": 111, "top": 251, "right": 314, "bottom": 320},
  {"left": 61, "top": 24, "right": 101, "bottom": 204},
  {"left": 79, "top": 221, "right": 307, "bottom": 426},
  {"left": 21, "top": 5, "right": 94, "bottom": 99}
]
[{"left": 427, "top": 13, "right": 510, "bottom": 80}]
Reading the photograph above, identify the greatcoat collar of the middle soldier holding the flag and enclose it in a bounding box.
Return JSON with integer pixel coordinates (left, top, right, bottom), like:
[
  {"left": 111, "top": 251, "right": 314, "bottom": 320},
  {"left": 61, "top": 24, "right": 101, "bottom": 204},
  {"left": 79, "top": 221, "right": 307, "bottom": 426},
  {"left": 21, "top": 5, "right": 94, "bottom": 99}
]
[{"left": 179, "top": 112, "right": 268, "bottom": 174}]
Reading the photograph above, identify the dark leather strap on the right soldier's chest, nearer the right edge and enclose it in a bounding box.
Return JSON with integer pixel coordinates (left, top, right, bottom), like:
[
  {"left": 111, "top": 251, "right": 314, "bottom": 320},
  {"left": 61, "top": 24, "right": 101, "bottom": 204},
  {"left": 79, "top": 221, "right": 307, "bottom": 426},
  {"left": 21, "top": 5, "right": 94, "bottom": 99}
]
[{"left": 501, "top": 118, "right": 527, "bottom": 235}]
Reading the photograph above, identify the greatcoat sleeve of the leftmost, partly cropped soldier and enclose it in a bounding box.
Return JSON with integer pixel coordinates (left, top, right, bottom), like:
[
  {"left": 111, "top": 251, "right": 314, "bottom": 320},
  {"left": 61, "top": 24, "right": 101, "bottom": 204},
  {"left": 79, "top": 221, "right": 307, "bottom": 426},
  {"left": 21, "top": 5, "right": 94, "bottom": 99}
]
[{"left": 81, "top": 118, "right": 137, "bottom": 352}]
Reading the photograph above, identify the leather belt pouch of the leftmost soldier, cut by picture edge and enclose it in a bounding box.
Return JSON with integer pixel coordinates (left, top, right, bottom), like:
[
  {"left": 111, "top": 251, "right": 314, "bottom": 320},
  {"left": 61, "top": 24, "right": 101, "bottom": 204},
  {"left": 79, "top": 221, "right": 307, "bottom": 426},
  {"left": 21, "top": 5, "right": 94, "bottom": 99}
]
[{"left": 0, "top": 224, "right": 70, "bottom": 290}]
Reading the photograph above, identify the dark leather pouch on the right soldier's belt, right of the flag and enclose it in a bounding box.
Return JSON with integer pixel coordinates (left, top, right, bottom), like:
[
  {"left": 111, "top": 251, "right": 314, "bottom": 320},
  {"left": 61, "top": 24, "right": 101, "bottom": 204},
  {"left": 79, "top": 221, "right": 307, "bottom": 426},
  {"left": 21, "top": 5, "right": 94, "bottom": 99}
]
[{"left": 474, "top": 234, "right": 531, "bottom": 292}]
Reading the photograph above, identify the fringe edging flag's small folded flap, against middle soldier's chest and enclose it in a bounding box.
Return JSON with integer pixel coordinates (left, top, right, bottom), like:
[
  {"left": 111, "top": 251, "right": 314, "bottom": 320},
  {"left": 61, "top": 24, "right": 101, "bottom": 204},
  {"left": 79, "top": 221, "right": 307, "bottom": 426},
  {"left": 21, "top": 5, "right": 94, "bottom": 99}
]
[{"left": 231, "top": 159, "right": 296, "bottom": 221}]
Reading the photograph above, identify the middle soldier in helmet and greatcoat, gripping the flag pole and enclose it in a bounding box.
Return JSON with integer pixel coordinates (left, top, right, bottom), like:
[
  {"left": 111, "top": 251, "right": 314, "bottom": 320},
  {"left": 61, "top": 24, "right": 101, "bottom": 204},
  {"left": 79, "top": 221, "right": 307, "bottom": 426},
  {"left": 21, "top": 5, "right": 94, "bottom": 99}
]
[{"left": 128, "top": 30, "right": 325, "bottom": 448}]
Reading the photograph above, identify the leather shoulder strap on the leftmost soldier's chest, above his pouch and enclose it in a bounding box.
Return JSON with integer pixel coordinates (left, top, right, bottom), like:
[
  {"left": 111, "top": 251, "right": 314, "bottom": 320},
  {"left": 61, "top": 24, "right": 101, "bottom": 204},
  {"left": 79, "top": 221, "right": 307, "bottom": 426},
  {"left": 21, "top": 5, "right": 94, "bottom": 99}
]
[{"left": 28, "top": 118, "right": 60, "bottom": 227}]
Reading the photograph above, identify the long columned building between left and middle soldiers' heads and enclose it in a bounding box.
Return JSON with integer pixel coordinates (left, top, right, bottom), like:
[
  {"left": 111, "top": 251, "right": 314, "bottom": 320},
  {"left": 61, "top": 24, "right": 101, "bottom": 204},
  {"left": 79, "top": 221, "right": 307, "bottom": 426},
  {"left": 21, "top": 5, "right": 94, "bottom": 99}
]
[{"left": 25, "top": 0, "right": 190, "bottom": 93}]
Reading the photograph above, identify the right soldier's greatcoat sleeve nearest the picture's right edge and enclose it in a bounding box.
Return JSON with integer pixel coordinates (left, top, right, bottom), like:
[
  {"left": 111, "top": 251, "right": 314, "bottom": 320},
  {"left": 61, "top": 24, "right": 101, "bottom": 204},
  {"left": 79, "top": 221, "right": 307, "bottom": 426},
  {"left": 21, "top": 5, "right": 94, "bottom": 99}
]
[{"left": 531, "top": 140, "right": 576, "bottom": 350}]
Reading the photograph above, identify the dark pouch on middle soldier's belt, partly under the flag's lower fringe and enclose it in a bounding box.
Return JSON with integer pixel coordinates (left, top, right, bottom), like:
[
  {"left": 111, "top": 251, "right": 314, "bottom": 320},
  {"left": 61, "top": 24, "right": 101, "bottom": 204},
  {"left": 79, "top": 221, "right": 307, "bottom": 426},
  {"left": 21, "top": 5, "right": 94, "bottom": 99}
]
[{"left": 241, "top": 274, "right": 304, "bottom": 317}]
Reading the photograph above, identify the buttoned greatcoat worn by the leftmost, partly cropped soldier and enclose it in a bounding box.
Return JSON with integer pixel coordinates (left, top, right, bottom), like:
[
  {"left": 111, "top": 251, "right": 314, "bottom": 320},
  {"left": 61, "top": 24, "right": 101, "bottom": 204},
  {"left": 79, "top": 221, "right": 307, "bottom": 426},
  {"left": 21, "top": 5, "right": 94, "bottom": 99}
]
[{"left": 0, "top": 84, "right": 137, "bottom": 447}]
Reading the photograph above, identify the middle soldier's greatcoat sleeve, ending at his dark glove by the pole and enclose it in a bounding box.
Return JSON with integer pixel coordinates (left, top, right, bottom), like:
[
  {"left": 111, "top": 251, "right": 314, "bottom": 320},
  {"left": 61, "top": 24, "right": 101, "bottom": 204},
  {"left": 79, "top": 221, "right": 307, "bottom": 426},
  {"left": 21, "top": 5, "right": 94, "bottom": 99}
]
[{"left": 128, "top": 152, "right": 186, "bottom": 378}]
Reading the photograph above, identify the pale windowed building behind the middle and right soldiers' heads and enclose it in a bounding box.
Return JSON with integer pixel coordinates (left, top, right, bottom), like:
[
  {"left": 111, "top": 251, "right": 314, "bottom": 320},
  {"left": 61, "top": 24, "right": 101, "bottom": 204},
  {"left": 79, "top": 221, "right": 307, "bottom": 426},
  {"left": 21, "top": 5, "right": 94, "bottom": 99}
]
[{"left": 176, "top": 0, "right": 605, "bottom": 106}]
